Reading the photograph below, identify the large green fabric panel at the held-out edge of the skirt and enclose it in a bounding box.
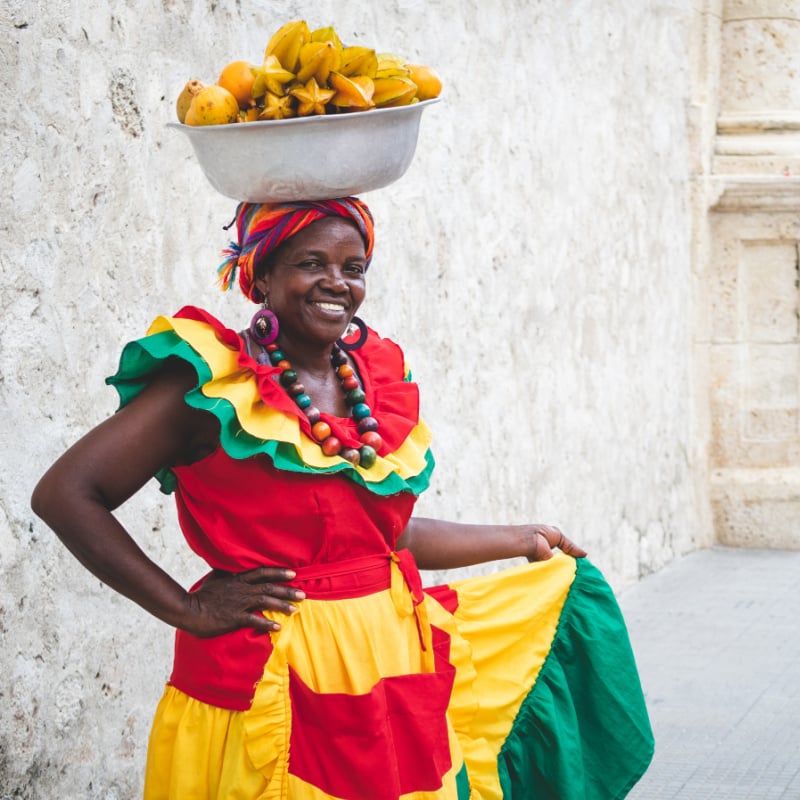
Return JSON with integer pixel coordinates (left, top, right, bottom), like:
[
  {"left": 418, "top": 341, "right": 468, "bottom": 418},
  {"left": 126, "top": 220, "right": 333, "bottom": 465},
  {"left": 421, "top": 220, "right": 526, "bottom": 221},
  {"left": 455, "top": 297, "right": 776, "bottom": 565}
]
[{"left": 498, "top": 559, "right": 653, "bottom": 800}]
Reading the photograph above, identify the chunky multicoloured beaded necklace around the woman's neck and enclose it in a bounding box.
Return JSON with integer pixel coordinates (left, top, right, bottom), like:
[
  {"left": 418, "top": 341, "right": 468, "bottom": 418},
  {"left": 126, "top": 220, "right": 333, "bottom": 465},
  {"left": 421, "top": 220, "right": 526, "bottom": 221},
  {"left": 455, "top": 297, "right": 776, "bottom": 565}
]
[{"left": 256, "top": 343, "right": 383, "bottom": 469}]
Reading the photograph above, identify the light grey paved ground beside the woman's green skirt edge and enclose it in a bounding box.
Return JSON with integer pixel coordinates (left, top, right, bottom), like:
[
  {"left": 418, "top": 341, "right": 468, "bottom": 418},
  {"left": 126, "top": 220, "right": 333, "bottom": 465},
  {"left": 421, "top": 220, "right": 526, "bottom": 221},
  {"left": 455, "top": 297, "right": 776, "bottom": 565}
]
[{"left": 620, "top": 548, "right": 800, "bottom": 800}]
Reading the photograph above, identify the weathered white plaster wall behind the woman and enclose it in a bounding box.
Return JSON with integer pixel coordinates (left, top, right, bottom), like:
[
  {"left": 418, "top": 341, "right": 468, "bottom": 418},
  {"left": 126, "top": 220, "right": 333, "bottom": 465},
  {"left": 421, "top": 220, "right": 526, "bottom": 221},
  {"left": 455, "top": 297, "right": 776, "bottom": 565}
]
[{"left": 0, "top": 0, "right": 705, "bottom": 798}]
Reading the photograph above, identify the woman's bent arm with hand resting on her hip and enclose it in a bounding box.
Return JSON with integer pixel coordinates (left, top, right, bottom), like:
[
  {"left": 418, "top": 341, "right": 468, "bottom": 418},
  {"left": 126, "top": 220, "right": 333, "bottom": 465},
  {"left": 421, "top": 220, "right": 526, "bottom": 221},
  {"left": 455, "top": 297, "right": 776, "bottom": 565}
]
[{"left": 31, "top": 364, "right": 302, "bottom": 636}]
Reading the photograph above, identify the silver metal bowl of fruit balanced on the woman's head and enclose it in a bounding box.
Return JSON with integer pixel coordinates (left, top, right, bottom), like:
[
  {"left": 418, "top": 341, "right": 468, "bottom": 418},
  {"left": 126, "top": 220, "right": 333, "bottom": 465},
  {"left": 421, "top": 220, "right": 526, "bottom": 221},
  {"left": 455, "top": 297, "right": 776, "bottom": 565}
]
[{"left": 167, "top": 98, "right": 439, "bottom": 203}]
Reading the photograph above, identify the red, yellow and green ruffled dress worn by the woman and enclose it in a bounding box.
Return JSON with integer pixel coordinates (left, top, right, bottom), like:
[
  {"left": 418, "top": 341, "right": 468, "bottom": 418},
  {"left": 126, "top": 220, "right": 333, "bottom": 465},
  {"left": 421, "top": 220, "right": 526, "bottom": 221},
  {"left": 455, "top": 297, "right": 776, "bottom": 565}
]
[{"left": 109, "top": 307, "right": 652, "bottom": 800}]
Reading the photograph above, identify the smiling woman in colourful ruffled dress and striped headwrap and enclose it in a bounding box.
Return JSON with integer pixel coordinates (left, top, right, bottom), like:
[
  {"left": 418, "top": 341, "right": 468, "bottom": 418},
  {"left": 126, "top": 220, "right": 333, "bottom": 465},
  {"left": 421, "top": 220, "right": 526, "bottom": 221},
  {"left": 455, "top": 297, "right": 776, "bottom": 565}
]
[{"left": 33, "top": 198, "right": 652, "bottom": 800}]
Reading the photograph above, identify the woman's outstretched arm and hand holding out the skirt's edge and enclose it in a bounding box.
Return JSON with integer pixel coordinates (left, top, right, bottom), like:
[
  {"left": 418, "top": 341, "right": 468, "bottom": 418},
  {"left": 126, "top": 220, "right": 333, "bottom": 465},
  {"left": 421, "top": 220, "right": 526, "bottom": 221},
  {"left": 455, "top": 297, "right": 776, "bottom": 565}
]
[{"left": 396, "top": 517, "right": 586, "bottom": 569}]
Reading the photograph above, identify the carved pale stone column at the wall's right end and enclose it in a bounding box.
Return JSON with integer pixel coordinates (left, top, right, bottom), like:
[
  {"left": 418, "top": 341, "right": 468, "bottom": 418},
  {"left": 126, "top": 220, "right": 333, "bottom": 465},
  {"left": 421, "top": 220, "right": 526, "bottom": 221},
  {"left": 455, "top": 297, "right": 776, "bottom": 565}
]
[{"left": 695, "top": 0, "right": 800, "bottom": 548}]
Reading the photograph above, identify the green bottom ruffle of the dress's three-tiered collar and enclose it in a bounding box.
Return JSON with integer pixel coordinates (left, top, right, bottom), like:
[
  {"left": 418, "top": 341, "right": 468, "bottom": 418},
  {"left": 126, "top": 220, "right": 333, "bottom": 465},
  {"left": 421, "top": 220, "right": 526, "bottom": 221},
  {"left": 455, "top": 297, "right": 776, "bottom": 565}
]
[{"left": 106, "top": 331, "right": 435, "bottom": 496}]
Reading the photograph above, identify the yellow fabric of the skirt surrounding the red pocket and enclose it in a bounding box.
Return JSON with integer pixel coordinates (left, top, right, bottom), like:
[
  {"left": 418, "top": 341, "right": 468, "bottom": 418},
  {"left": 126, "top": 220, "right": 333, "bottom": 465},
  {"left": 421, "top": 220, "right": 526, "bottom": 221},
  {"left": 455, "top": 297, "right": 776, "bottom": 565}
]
[{"left": 145, "top": 554, "right": 576, "bottom": 800}]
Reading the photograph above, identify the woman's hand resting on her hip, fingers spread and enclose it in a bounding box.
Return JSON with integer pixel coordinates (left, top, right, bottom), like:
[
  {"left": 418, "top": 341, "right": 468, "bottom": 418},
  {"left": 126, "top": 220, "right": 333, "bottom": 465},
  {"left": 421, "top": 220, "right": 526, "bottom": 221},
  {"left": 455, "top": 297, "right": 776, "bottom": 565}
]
[{"left": 179, "top": 567, "right": 305, "bottom": 638}]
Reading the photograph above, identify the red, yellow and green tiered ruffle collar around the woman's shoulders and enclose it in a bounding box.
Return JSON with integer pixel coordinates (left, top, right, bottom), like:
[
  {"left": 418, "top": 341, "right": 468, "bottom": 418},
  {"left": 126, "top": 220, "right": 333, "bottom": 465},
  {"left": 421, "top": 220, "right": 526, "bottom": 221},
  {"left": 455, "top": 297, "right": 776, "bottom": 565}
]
[{"left": 106, "top": 306, "right": 434, "bottom": 495}]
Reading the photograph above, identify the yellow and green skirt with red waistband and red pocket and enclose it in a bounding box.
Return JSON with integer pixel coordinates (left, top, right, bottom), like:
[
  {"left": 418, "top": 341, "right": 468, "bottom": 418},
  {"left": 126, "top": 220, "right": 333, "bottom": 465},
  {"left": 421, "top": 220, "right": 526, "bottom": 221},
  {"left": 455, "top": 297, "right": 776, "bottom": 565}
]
[{"left": 144, "top": 551, "right": 653, "bottom": 800}]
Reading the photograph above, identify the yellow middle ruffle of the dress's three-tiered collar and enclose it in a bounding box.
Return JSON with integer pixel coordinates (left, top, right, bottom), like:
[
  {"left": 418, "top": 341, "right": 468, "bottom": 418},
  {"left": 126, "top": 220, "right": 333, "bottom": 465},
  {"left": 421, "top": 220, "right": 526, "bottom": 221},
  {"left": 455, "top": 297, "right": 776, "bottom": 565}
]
[{"left": 147, "top": 317, "right": 432, "bottom": 483}]
